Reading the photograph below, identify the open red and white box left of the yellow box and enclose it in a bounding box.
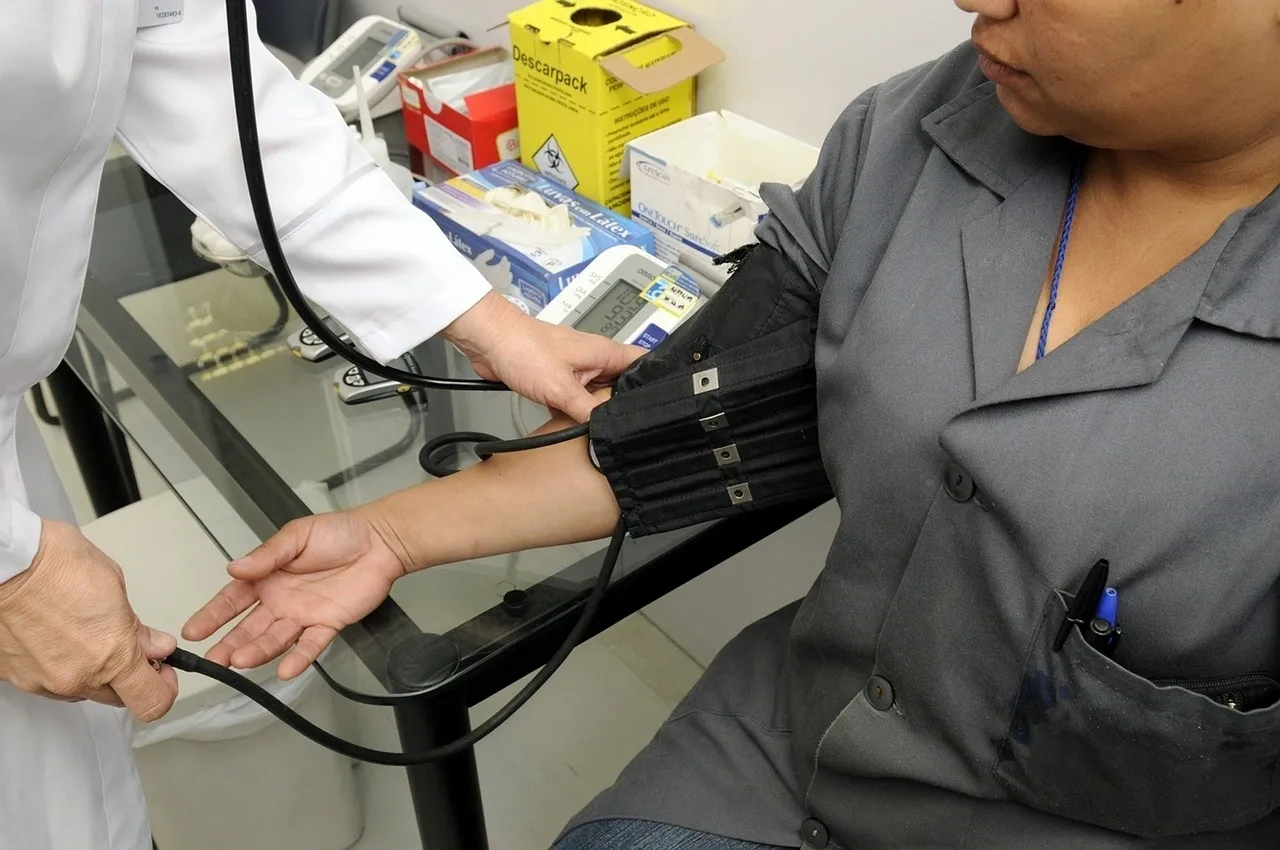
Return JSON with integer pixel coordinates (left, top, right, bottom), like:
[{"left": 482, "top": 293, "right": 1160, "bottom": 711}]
[{"left": 399, "top": 47, "right": 520, "bottom": 175}]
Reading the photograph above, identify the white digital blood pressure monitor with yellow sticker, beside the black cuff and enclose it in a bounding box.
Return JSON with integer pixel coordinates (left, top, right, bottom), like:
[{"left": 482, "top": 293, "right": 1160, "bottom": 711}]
[{"left": 538, "top": 246, "right": 707, "bottom": 349}]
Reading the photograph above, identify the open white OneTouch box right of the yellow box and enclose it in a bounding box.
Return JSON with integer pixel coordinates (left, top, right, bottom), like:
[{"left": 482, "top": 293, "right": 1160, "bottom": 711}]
[{"left": 623, "top": 111, "right": 819, "bottom": 282}]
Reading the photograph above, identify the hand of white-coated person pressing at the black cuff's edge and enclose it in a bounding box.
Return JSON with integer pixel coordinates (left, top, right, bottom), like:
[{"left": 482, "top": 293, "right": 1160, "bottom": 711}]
[{"left": 444, "top": 292, "right": 644, "bottom": 422}]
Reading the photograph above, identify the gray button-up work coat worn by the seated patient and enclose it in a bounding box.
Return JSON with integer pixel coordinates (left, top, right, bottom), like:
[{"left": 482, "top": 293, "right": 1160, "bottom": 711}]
[{"left": 568, "top": 45, "right": 1280, "bottom": 850}]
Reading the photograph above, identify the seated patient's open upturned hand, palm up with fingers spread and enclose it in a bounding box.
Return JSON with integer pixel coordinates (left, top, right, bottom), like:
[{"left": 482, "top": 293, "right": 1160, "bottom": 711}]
[{"left": 182, "top": 509, "right": 408, "bottom": 680}]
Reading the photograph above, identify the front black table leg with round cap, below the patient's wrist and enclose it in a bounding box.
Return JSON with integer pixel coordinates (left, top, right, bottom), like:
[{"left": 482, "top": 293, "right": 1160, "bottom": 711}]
[{"left": 388, "top": 635, "right": 489, "bottom": 850}]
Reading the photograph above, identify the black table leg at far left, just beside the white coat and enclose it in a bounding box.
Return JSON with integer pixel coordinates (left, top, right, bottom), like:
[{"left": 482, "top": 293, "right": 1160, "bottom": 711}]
[{"left": 47, "top": 361, "right": 138, "bottom": 516}]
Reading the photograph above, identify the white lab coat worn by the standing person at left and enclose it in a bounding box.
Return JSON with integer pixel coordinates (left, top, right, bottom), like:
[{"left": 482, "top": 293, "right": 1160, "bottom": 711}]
[{"left": 0, "top": 0, "right": 489, "bottom": 850}]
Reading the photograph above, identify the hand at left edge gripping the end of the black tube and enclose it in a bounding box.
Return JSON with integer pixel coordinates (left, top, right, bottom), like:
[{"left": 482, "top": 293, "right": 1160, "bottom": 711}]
[{"left": 0, "top": 521, "right": 178, "bottom": 722}]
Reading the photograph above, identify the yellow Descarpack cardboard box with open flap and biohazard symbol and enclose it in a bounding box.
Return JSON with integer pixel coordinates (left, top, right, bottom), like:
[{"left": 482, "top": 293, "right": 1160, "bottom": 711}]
[{"left": 508, "top": 0, "right": 724, "bottom": 214}]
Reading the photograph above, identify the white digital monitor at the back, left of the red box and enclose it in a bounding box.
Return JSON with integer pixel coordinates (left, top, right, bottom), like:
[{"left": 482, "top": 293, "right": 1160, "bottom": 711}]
[{"left": 298, "top": 15, "right": 428, "bottom": 122}]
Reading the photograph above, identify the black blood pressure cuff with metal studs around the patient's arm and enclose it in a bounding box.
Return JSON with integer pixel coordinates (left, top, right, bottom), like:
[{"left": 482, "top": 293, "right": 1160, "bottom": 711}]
[{"left": 590, "top": 245, "right": 832, "bottom": 536}]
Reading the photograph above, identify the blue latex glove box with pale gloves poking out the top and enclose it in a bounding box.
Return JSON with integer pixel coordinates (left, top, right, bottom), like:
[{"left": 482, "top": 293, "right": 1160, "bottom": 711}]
[{"left": 413, "top": 163, "right": 654, "bottom": 315}]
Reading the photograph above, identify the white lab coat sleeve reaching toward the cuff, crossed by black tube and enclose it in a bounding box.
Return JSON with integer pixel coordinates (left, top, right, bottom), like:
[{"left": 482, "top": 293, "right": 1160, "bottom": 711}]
[{"left": 118, "top": 0, "right": 490, "bottom": 362}]
